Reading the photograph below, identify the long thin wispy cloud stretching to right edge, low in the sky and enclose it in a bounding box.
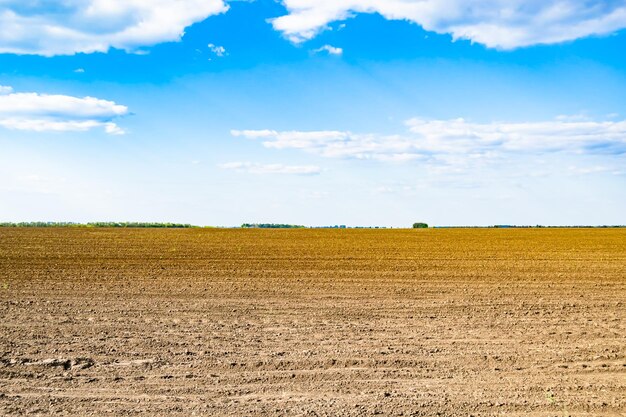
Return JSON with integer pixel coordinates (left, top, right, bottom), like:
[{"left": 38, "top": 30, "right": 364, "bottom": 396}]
[{"left": 231, "top": 118, "right": 626, "bottom": 165}]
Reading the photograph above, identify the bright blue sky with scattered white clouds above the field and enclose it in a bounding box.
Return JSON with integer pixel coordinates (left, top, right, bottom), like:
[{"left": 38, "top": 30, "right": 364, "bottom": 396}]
[{"left": 0, "top": 0, "right": 626, "bottom": 227}]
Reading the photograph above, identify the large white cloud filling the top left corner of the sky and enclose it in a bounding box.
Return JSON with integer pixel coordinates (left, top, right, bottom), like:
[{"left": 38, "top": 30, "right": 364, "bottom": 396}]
[{"left": 0, "top": 0, "right": 228, "bottom": 56}]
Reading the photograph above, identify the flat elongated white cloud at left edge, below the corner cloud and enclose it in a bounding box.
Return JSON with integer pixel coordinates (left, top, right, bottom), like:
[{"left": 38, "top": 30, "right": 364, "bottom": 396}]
[{"left": 0, "top": 87, "right": 128, "bottom": 135}]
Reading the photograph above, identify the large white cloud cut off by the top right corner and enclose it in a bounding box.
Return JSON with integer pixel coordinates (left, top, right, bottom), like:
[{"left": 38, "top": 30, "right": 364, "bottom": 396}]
[{"left": 271, "top": 0, "right": 626, "bottom": 49}]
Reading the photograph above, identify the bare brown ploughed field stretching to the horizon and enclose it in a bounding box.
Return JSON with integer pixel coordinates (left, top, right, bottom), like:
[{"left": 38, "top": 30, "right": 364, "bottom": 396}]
[{"left": 0, "top": 228, "right": 626, "bottom": 416}]
